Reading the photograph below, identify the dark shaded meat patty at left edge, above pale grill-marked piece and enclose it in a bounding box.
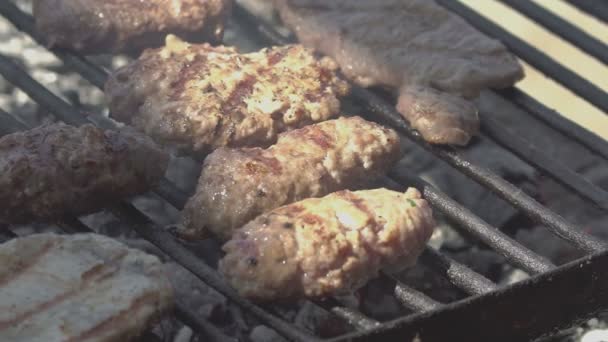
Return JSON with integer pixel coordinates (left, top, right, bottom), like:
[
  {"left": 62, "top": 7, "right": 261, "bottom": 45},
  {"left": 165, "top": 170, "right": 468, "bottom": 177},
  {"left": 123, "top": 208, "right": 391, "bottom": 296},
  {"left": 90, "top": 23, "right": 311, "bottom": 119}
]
[{"left": 0, "top": 124, "right": 168, "bottom": 224}]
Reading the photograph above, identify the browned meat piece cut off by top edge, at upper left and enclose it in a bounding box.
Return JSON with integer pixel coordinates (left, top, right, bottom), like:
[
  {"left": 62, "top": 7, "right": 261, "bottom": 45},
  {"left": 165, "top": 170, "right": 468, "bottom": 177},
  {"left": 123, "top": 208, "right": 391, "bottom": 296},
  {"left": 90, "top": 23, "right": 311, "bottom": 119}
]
[{"left": 33, "top": 0, "right": 232, "bottom": 54}]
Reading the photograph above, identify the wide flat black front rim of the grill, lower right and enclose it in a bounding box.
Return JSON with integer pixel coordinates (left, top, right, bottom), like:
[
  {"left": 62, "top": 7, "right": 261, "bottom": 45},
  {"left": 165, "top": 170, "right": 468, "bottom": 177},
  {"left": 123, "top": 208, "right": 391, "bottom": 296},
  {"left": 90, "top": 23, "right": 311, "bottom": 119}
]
[{"left": 327, "top": 251, "right": 608, "bottom": 342}]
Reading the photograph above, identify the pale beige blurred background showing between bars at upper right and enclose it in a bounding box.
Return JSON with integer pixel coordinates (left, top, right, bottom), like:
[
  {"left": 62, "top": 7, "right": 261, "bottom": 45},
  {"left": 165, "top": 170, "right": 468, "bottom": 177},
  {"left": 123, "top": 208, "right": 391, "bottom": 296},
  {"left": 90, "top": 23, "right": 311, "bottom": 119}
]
[{"left": 458, "top": 0, "right": 608, "bottom": 139}]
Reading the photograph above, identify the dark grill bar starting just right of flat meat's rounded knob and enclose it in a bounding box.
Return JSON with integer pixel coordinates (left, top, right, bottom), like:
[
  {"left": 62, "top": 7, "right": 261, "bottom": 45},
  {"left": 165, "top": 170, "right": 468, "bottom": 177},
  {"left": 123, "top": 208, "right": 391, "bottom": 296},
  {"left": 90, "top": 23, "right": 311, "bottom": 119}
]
[{"left": 481, "top": 113, "right": 608, "bottom": 210}]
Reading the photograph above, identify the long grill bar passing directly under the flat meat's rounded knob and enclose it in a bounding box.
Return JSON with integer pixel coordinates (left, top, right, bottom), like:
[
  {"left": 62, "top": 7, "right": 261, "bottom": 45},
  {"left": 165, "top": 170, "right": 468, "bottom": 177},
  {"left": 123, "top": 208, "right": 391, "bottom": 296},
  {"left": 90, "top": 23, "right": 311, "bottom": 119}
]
[{"left": 234, "top": 5, "right": 608, "bottom": 252}]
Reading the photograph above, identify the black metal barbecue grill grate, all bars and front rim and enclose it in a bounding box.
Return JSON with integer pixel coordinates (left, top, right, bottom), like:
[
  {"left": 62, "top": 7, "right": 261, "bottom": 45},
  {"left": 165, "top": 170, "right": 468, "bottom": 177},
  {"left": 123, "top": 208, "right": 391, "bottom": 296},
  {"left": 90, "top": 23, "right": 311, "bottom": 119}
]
[{"left": 0, "top": 0, "right": 608, "bottom": 342}]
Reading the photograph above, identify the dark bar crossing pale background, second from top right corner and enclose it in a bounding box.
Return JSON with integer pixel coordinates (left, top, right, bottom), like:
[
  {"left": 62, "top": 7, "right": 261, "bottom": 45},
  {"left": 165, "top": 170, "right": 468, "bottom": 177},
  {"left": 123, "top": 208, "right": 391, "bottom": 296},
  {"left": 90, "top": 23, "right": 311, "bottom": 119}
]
[{"left": 501, "top": 0, "right": 608, "bottom": 64}]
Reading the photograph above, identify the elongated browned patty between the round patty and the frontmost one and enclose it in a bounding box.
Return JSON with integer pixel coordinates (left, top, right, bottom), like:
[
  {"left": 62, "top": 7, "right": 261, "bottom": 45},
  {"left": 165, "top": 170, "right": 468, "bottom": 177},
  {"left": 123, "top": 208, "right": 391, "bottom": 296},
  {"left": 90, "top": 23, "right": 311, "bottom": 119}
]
[{"left": 180, "top": 117, "right": 400, "bottom": 239}]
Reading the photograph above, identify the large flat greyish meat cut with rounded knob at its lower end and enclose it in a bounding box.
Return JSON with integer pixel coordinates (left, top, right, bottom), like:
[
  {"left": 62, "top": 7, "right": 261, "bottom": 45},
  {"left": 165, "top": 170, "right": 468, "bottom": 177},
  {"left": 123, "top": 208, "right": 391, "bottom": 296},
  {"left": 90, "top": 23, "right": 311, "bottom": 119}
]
[{"left": 274, "top": 0, "right": 523, "bottom": 145}]
